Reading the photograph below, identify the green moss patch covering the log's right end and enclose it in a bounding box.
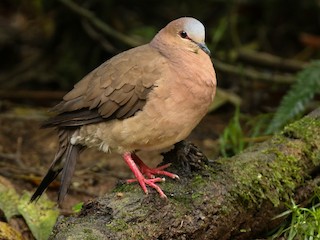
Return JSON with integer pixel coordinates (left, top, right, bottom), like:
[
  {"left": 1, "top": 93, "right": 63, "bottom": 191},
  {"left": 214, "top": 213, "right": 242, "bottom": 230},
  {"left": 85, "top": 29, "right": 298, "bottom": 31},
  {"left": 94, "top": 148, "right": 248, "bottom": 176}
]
[{"left": 230, "top": 114, "right": 320, "bottom": 207}]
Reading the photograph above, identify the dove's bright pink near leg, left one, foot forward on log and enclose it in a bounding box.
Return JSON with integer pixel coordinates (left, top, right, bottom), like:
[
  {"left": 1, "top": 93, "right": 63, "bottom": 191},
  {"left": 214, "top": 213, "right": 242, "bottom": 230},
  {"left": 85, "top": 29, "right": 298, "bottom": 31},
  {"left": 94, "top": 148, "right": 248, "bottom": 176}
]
[{"left": 123, "top": 152, "right": 167, "bottom": 198}]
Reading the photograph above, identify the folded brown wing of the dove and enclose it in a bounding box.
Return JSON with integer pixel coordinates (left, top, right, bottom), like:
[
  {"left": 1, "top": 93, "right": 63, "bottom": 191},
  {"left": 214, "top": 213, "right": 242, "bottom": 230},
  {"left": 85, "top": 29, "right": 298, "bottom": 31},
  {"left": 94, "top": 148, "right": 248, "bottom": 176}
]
[{"left": 43, "top": 45, "right": 165, "bottom": 127}]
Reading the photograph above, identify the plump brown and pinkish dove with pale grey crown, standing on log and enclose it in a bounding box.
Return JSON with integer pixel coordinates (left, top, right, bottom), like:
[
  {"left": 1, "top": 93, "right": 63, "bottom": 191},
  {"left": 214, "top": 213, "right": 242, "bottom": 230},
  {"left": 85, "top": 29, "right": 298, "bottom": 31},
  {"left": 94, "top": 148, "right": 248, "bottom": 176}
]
[{"left": 31, "top": 17, "right": 216, "bottom": 203}]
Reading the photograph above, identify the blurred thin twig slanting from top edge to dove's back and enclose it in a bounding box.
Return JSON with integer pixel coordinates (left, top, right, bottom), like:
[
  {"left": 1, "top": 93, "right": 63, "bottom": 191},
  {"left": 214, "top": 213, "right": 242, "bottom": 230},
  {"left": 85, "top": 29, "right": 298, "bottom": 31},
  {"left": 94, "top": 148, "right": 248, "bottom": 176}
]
[{"left": 60, "top": 0, "right": 141, "bottom": 47}]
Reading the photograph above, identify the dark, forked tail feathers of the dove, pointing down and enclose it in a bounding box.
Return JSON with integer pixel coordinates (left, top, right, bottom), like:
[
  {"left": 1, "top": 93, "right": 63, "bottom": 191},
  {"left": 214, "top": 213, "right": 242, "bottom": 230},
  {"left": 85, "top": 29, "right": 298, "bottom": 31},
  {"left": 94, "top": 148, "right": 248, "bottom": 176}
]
[{"left": 30, "top": 128, "right": 83, "bottom": 204}]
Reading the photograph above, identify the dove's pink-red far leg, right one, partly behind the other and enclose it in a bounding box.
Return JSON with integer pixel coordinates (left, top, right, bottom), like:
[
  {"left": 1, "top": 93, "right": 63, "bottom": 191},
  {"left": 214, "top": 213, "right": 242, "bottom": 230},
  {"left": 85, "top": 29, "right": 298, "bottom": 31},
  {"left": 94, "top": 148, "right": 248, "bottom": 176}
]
[{"left": 131, "top": 153, "right": 179, "bottom": 179}]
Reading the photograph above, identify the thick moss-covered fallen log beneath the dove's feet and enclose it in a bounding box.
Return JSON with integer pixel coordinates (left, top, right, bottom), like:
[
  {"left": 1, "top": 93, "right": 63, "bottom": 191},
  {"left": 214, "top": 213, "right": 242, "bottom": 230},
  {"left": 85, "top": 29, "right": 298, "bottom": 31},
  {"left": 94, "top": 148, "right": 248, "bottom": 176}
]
[{"left": 51, "top": 109, "right": 320, "bottom": 240}]
